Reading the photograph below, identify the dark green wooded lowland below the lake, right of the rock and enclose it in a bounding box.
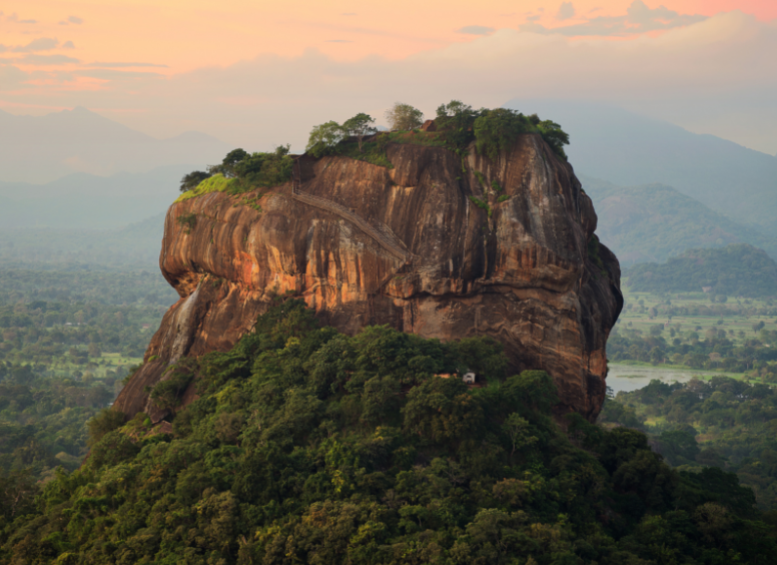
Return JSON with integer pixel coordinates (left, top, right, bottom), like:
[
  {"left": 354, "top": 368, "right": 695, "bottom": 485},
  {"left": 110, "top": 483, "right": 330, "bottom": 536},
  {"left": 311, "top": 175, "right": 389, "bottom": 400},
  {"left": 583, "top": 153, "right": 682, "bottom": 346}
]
[{"left": 599, "top": 377, "right": 777, "bottom": 510}]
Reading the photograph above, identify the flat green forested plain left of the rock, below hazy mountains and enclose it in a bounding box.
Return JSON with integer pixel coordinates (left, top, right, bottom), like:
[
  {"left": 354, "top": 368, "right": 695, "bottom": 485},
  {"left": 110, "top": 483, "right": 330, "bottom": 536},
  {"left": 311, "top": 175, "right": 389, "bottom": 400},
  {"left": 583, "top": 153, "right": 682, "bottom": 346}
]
[{"left": 0, "top": 264, "right": 178, "bottom": 482}]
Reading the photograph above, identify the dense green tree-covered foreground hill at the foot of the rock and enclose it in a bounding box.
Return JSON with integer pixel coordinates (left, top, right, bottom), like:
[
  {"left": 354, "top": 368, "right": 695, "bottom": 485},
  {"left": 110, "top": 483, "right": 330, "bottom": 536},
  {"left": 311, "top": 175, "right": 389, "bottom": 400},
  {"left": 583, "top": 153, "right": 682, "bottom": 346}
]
[{"left": 0, "top": 301, "right": 777, "bottom": 565}]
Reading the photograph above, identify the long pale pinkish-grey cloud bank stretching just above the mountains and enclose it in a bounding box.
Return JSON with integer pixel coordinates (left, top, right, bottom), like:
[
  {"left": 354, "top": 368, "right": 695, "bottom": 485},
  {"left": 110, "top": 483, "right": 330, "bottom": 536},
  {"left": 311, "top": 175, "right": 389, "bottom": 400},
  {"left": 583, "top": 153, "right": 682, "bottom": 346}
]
[{"left": 0, "top": 12, "right": 777, "bottom": 154}]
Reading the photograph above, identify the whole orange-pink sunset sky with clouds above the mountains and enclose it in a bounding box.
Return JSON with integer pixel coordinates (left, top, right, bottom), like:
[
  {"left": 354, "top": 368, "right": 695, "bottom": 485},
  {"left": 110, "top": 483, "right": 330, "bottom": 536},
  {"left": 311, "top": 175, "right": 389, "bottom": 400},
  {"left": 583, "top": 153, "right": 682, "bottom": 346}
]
[{"left": 0, "top": 0, "right": 777, "bottom": 154}]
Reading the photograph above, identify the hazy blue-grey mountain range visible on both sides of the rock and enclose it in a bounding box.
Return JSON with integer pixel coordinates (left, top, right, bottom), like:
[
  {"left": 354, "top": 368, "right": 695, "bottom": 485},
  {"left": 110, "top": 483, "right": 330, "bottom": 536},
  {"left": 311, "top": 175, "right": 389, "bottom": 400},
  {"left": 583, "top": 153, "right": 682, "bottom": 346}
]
[{"left": 0, "top": 100, "right": 777, "bottom": 265}]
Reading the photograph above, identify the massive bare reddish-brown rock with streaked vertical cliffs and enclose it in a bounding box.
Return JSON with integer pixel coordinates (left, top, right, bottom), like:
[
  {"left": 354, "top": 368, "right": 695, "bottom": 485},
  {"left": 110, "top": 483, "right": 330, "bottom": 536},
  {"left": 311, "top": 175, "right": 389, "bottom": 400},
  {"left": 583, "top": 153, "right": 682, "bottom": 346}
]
[{"left": 115, "top": 134, "right": 622, "bottom": 421}]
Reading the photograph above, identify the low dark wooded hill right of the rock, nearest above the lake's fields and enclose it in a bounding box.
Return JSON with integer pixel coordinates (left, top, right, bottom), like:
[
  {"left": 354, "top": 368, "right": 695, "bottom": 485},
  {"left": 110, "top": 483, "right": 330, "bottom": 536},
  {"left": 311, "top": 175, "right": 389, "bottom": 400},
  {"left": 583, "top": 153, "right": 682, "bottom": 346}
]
[{"left": 624, "top": 243, "right": 777, "bottom": 297}]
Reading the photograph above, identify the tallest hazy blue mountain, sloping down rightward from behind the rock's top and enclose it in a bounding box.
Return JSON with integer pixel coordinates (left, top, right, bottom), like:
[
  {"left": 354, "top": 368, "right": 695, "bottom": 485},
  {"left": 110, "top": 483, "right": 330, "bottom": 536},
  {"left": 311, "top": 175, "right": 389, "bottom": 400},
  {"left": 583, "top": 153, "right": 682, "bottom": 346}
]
[{"left": 505, "top": 99, "right": 777, "bottom": 237}]
